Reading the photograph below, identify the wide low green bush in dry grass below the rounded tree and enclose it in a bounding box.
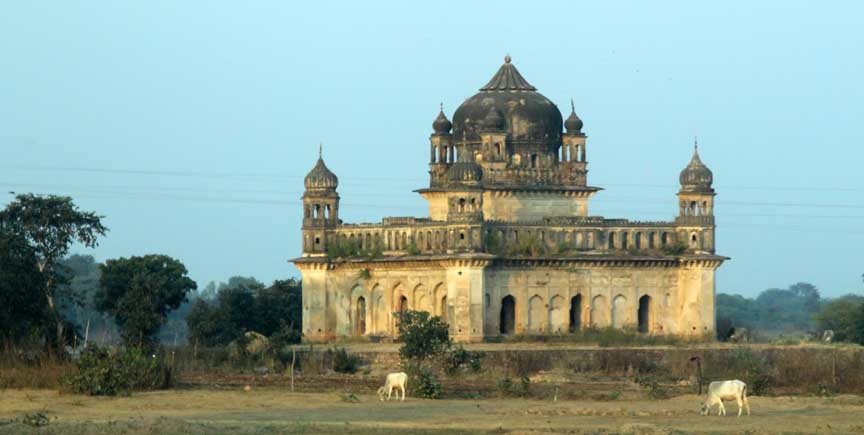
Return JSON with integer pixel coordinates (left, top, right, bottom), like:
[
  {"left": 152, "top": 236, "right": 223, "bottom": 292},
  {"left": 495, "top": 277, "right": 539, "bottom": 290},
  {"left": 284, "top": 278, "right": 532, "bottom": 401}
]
[{"left": 65, "top": 344, "right": 172, "bottom": 396}]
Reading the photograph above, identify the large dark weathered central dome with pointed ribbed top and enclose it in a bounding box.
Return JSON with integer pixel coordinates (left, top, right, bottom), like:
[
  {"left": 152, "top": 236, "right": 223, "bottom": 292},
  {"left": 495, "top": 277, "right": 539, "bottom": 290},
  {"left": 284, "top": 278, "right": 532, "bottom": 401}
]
[{"left": 453, "top": 56, "right": 562, "bottom": 142}]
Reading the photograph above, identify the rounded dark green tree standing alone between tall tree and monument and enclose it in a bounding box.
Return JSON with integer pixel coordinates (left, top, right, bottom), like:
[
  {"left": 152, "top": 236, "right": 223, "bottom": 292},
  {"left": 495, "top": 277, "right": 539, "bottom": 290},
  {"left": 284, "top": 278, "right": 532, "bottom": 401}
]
[{"left": 96, "top": 255, "right": 197, "bottom": 346}]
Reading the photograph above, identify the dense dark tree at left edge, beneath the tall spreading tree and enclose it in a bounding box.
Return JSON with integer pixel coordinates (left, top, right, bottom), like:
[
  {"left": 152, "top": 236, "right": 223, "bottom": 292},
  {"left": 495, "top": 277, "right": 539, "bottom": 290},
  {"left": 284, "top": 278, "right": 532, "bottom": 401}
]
[{"left": 0, "top": 229, "right": 51, "bottom": 341}]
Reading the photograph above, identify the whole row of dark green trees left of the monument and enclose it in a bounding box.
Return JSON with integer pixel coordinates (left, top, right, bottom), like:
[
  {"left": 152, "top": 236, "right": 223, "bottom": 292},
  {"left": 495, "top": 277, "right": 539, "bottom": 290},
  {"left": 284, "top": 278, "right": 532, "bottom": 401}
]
[{"left": 0, "top": 194, "right": 302, "bottom": 348}]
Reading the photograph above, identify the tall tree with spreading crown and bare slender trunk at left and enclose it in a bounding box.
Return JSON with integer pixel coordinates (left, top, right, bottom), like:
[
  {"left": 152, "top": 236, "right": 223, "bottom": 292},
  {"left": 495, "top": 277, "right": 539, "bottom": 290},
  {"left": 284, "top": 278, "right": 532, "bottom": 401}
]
[{"left": 0, "top": 194, "right": 108, "bottom": 340}]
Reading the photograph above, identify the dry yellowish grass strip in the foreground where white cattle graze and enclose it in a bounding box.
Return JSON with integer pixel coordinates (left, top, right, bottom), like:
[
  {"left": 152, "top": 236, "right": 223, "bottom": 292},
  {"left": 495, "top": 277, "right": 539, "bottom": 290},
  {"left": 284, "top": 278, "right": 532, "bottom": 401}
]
[{"left": 0, "top": 388, "right": 864, "bottom": 434}]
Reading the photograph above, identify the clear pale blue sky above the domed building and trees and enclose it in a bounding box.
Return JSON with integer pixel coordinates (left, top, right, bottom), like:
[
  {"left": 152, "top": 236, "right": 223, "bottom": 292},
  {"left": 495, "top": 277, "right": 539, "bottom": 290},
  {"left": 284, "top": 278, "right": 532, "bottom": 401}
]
[{"left": 0, "top": 0, "right": 864, "bottom": 296}]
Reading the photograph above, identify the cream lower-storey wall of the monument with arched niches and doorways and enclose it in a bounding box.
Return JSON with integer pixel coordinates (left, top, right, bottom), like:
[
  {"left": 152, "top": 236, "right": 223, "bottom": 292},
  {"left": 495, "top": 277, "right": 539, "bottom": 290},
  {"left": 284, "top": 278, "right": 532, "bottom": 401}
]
[{"left": 301, "top": 260, "right": 715, "bottom": 341}]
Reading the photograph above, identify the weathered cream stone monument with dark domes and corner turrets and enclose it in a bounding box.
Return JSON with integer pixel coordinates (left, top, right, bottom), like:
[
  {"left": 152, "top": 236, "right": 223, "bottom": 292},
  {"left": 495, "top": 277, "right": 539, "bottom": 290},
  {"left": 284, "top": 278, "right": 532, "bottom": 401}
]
[{"left": 292, "top": 56, "right": 726, "bottom": 341}]
